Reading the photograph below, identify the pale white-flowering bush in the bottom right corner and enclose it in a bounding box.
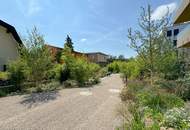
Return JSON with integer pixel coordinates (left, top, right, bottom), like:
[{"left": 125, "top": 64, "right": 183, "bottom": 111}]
[{"left": 162, "top": 108, "right": 190, "bottom": 130}]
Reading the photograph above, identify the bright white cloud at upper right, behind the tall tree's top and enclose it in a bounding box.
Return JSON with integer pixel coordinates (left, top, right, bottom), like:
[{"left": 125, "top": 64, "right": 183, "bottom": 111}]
[{"left": 152, "top": 2, "right": 177, "bottom": 20}]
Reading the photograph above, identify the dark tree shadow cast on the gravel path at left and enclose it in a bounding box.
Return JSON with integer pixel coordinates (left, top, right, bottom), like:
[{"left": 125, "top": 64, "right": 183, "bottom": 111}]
[{"left": 20, "top": 91, "right": 60, "bottom": 108}]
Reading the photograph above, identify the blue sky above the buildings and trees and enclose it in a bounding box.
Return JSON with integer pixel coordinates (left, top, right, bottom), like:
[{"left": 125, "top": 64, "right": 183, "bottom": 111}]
[{"left": 0, "top": 0, "right": 180, "bottom": 58}]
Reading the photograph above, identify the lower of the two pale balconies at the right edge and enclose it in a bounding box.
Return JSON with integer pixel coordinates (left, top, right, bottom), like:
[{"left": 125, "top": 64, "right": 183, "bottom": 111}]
[{"left": 177, "top": 25, "right": 190, "bottom": 47}]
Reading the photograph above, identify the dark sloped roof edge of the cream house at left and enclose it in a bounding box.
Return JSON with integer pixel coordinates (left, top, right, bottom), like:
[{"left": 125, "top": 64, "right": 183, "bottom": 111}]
[{"left": 0, "top": 20, "right": 22, "bottom": 45}]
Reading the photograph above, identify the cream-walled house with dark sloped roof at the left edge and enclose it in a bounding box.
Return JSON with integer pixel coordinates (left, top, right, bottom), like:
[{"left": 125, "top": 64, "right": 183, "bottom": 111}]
[{"left": 0, "top": 20, "right": 22, "bottom": 71}]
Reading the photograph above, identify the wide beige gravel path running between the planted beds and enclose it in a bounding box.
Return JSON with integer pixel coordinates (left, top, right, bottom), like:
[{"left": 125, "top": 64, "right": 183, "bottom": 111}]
[{"left": 0, "top": 75, "right": 123, "bottom": 130}]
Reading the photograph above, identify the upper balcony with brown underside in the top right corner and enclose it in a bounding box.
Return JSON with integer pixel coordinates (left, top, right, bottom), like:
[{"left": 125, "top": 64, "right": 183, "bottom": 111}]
[{"left": 174, "top": 0, "right": 190, "bottom": 24}]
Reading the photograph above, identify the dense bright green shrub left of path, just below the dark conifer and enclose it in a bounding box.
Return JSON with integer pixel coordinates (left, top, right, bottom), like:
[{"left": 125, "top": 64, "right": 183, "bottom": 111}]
[{"left": 62, "top": 46, "right": 100, "bottom": 86}]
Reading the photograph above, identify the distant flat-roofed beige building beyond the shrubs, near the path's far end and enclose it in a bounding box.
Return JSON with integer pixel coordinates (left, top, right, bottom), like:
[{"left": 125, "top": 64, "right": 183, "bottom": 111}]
[{"left": 85, "top": 52, "right": 110, "bottom": 65}]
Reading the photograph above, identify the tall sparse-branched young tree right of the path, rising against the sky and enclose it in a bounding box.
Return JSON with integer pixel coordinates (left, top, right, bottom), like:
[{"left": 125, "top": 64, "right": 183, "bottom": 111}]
[{"left": 128, "top": 5, "right": 170, "bottom": 84}]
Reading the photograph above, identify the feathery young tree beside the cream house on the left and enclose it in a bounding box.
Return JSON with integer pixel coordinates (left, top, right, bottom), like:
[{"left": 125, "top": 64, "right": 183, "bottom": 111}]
[{"left": 20, "top": 27, "right": 53, "bottom": 86}]
